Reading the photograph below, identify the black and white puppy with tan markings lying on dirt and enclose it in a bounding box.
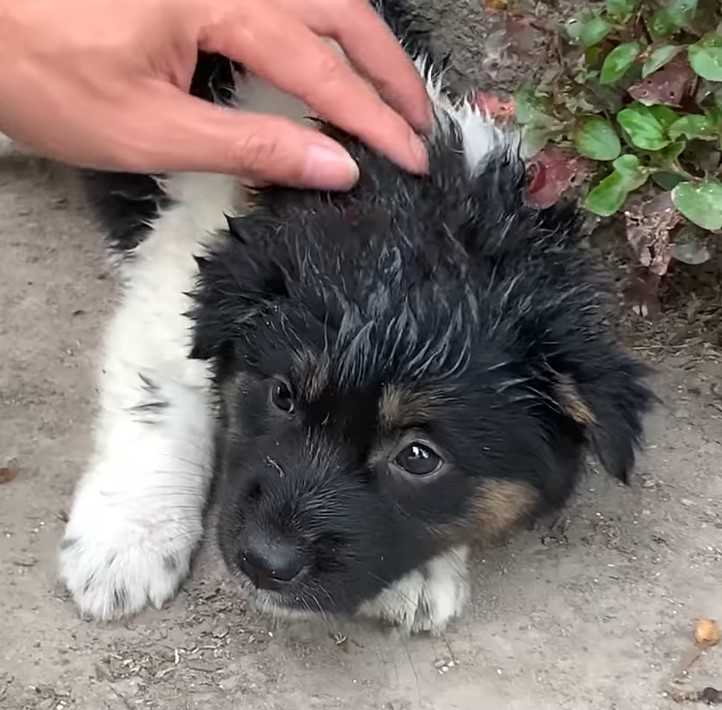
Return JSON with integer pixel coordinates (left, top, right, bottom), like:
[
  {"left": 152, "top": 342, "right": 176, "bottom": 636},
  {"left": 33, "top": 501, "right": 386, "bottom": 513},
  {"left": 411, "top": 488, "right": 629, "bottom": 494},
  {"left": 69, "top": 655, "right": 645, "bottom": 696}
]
[{"left": 61, "top": 3, "right": 651, "bottom": 631}]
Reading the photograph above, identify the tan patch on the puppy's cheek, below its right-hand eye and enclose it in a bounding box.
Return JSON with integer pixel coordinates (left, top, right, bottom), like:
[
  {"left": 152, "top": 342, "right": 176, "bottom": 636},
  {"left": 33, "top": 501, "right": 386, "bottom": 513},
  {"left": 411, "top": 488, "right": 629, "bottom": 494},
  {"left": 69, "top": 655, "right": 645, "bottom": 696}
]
[{"left": 468, "top": 480, "right": 539, "bottom": 537}]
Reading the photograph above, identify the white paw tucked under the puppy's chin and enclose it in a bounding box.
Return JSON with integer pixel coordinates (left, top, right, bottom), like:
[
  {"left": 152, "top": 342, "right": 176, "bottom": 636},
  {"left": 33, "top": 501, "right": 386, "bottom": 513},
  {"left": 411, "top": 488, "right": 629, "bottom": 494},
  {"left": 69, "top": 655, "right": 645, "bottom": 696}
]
[{"left": 360, "top": 547, "right": 469, "bottom": 634}]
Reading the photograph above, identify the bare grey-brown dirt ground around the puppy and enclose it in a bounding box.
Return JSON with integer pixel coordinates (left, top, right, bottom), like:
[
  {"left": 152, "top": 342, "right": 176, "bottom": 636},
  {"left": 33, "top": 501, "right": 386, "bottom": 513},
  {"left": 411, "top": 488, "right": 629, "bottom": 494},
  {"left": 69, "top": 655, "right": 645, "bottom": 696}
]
[{"left": 0, "top": 2, "right": 722, "bottom": 710}]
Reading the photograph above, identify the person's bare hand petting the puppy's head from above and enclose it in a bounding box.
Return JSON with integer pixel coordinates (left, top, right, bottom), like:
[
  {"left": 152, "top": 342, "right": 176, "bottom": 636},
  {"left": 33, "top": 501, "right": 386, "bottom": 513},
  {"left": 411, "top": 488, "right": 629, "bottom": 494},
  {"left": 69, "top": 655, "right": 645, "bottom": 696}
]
[{"left": 0, "top": 0, "right": 431, "bottom": 190}]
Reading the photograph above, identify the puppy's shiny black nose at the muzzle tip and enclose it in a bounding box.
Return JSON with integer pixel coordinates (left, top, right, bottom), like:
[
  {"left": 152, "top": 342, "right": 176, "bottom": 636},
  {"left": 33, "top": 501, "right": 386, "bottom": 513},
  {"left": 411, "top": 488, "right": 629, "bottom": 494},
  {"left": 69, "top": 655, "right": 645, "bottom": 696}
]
[{"left": 238, "top": 533, "right": 305, "bottom": 590}]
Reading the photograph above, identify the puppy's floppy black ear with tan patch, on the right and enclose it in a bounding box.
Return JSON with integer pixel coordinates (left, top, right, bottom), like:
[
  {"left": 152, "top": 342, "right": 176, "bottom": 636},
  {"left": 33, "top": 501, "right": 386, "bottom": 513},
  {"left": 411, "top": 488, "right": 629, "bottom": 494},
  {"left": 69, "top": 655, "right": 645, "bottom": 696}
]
[{"left": 553, "top": 353, "right": 654, "bottom": 483}]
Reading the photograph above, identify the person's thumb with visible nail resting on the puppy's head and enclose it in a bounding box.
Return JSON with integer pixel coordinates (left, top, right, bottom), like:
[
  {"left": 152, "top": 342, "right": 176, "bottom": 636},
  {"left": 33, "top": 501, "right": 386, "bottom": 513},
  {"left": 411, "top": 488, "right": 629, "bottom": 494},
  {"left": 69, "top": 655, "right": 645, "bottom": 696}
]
[{"left": 116, "top": 84, "right": 359, "bottom": 190}]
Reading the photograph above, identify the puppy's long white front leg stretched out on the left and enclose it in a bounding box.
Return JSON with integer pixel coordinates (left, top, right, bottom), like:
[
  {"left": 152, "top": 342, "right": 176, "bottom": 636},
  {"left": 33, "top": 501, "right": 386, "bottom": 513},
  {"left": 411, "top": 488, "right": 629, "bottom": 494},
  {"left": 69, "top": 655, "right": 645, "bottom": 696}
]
[{"left": 60, "top": 177, "right": 231, "bottom": 619}]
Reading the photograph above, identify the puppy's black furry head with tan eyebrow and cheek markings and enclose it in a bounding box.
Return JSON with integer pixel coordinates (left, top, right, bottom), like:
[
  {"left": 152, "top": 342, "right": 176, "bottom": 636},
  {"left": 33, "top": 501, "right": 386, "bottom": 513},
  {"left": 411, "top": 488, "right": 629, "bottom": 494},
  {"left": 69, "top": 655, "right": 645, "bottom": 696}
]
[{"left": 188, "top": 132, "right": 648, "bottom": 612}]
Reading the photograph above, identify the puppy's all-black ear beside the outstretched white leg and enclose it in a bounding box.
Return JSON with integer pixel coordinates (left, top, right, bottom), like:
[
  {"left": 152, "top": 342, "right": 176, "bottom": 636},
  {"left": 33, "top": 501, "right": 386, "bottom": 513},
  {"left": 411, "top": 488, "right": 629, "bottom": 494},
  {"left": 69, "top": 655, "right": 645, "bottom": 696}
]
[{"left": 187, "top": 240, "right": 288, "bottom": 360}]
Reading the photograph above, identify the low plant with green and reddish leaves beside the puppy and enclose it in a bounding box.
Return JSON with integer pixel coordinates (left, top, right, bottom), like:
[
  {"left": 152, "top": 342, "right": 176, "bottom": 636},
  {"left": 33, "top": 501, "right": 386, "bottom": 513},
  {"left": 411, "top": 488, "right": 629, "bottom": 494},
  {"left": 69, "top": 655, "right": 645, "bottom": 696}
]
[{"left": 515, "top": 0, "right": 722, "bottom": 273}]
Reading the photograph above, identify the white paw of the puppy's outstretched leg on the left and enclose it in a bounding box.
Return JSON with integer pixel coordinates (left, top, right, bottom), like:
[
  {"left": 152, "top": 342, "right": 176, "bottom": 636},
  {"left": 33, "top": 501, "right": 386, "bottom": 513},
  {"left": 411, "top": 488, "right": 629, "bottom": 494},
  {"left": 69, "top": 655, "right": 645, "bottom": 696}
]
[{"left": 60, "top": 486, "right": 201, "bottom": 620}]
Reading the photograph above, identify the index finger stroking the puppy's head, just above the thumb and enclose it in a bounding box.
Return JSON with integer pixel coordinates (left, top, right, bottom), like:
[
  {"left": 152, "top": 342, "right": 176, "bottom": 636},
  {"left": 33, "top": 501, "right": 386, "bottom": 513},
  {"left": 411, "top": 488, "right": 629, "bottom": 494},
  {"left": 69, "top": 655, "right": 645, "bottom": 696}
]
[{"left": 200, "top": 0, "right": 428, "bottom": 173}]
